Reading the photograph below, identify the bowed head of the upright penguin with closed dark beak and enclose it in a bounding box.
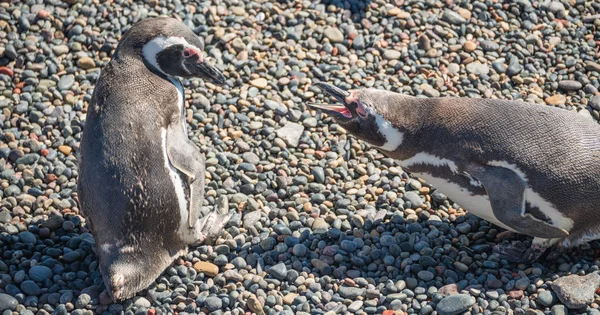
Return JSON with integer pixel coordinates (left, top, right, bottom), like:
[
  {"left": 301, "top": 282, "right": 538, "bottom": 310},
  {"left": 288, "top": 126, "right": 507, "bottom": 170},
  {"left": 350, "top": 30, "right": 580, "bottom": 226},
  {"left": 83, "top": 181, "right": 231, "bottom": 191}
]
[{"left": 115, "top": 17, "right": 225, "bottom": 85}]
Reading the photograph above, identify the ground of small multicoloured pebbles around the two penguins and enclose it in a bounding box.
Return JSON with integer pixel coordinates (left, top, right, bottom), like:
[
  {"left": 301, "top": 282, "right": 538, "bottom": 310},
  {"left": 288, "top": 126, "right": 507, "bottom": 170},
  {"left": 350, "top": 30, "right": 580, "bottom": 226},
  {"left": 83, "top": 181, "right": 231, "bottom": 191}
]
[{"left": 0, "top": 0, "right": 600, "bottom": 315}]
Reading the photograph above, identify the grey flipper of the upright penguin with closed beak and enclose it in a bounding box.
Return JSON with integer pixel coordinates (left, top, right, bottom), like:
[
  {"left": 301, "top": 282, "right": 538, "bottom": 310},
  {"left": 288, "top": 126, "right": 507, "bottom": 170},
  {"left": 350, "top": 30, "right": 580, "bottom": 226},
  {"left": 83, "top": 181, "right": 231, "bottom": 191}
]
[{"left": 166, "top": 123, "right": 206, "bottom": 228}]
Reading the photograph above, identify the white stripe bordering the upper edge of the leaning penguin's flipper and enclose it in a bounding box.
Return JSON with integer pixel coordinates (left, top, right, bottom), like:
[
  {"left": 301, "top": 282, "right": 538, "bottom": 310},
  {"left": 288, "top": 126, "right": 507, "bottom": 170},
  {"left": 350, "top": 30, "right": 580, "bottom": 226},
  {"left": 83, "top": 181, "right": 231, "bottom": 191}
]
[{"left": 488, "top": 161, "right": 573, "bottom": 231}]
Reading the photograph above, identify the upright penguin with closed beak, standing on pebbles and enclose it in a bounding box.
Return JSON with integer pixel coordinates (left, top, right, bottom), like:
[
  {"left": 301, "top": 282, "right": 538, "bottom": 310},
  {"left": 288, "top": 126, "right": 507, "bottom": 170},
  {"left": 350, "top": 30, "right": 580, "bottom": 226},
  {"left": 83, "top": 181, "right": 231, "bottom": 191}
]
[{"left": 78, "top": 18, "right": 230, "bottom": 300}]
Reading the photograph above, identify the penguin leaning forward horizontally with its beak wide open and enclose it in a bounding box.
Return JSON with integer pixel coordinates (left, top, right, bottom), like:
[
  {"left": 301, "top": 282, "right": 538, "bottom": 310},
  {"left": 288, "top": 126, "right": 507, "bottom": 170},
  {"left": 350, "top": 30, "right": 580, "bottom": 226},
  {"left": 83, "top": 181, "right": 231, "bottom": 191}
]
[{"left": 310, "top": 83, "right": 600, "bottom": 263}]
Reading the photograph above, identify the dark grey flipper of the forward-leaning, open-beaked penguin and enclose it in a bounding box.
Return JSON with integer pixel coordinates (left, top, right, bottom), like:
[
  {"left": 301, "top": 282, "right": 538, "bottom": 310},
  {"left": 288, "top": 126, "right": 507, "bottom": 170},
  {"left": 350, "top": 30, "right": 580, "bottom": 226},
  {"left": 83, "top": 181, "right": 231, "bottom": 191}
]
[{"left": 469, "top": 165, "right": 569, "bottom": 239}]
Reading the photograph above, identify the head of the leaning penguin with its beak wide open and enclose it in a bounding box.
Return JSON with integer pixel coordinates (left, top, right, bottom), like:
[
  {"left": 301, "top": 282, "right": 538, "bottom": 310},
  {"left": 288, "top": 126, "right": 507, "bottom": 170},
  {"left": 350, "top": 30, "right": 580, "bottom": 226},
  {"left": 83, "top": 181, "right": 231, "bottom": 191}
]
[{"left": 308, "top": 82, "right": 389, "bottom": 146}]
